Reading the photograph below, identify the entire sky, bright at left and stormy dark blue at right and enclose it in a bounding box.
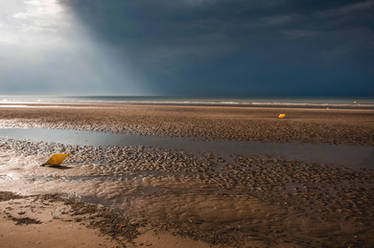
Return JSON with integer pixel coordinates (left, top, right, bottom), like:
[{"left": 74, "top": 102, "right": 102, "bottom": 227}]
[{"left": 0, "top": 0, "right": 374, "bottom": 97}]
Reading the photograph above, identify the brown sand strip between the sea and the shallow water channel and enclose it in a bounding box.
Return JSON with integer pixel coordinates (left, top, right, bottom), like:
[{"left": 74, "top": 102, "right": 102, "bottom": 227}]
[{"left": 0, "top": 104, "right": 374, "bottom": 145}]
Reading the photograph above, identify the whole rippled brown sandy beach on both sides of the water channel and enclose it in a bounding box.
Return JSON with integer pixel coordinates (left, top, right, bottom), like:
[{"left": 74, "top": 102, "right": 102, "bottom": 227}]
[{"left": 0, "top": 103, "right": 374, "bottom": 247}]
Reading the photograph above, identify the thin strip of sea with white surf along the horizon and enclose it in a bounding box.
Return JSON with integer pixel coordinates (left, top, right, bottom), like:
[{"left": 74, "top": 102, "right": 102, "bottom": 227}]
[{"left": 0, "top": 95, "right": 374, "bottom": 109}]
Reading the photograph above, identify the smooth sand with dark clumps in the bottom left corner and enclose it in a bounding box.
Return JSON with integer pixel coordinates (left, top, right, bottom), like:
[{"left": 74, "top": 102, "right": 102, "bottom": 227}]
[{"left": 0, "top": 191, "right": 214, "bottom": 248}]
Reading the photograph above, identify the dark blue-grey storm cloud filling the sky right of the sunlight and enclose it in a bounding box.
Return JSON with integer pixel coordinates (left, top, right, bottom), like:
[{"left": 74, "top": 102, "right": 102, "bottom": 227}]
[{"left": 60, "top": 0, "right": 374, "bottom": 96}]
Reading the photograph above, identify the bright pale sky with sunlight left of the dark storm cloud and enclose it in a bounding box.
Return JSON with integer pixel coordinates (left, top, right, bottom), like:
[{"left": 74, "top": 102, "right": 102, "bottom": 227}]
[{"left": 0, "top": 0, "right": 146, "bottom": 95}]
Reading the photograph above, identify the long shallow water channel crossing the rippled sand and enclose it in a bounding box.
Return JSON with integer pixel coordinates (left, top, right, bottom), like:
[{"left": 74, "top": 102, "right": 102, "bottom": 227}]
[{"left": 0, "top": 128, "right": 374, "bottom": 168}]
